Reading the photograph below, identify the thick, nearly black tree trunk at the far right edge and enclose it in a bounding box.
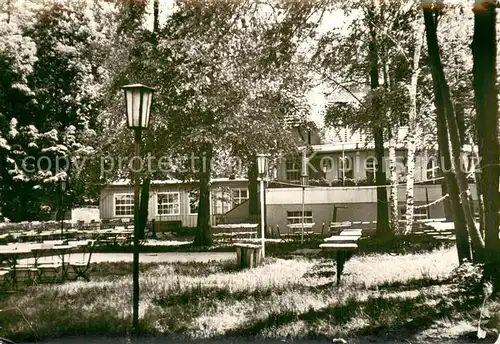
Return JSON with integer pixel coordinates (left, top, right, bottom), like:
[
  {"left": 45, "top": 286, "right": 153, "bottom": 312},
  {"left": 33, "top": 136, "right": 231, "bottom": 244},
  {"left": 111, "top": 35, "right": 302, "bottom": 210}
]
[{"left": 472, "top": 0, "right": 500, "bottom": 282}]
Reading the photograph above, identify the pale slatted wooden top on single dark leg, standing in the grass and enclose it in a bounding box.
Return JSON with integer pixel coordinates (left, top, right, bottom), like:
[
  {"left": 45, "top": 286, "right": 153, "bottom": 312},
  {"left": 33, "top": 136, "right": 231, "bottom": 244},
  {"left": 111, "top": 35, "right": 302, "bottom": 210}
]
[{"left": 319, "top": 230, "right": 361, "bottom": 285}]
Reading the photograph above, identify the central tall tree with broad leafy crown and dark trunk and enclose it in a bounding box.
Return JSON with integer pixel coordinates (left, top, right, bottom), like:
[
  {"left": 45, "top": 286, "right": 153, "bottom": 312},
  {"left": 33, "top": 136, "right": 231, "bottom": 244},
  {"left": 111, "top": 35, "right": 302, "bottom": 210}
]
[{"left": 112, "top": 1, "right": 314, "bottom": 246}]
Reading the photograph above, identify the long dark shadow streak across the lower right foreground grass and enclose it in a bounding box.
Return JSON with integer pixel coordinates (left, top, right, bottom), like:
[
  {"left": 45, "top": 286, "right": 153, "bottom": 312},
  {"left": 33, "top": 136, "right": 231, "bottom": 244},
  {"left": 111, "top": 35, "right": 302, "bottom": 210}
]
[{"left": 227, "top": 288, "right": 476, "bottom": 338}]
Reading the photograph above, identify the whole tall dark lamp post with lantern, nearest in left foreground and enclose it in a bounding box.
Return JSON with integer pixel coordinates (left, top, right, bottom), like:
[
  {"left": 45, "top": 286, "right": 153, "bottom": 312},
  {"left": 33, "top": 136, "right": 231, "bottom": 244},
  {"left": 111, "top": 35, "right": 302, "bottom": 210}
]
[{"left": 122, "top": 84, "right": 154, "bottom": 333}]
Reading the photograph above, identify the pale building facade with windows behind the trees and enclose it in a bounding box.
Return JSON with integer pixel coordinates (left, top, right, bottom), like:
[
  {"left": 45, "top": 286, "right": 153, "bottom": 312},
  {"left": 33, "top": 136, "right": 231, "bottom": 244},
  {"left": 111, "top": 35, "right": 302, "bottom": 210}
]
[{"left": 100, "top": 123, "right": 476, "bottom": 231}]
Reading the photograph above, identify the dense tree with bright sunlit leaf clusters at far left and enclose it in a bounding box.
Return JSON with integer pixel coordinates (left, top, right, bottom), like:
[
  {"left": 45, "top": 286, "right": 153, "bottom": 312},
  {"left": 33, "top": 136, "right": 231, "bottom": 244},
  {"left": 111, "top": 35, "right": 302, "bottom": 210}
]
[{"left": 0, "top": 1, "right": 111, "bottom": 220}]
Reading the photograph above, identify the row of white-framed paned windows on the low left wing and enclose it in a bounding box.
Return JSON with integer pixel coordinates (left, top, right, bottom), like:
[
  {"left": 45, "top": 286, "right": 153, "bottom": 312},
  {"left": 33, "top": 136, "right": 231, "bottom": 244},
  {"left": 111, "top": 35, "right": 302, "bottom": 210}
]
[{"left": 114, "top": 189, "right": 248, "bottom": 216}]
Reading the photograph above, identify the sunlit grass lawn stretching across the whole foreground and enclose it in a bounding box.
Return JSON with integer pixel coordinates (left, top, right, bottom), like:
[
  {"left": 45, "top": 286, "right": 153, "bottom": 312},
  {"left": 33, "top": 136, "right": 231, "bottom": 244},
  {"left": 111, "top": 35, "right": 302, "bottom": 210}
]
[{"left": 0, "top": 248, "right": 500, "bottom": 342}]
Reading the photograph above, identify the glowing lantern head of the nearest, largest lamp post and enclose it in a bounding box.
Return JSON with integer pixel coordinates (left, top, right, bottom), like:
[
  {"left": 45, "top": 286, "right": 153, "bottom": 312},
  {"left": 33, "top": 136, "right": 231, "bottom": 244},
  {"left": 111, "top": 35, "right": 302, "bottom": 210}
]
[{"left": 122, "top": 84, "right": 154, "bottom": 129}]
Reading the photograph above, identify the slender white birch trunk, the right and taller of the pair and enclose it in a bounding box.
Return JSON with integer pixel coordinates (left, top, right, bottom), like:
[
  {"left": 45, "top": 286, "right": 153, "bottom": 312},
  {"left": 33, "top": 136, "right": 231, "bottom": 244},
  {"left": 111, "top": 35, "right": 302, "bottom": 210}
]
[{"left": 404, "top": 26, "right": 424, "bottom": 234}]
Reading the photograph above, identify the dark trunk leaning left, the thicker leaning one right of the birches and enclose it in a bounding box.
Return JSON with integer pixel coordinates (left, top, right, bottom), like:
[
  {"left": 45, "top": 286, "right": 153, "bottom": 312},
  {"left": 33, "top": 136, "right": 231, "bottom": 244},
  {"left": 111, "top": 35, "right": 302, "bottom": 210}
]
[{"left": 423, "top": 6, "right": 471, "bottom": 264}]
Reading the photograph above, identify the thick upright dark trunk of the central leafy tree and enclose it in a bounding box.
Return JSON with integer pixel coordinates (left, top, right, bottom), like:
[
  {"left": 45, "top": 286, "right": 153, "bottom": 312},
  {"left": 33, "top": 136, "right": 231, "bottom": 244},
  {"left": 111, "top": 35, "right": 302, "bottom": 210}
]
[{"left": 193, "top": 143, "right": 213, "bottom": 247}]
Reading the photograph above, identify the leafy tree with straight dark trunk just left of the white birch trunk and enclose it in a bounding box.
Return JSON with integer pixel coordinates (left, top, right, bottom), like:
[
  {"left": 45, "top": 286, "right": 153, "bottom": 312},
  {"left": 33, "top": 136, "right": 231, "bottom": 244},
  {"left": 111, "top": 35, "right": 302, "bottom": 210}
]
[{"left": 319, "top": 1, "right": 417, "bottom": 237}]
